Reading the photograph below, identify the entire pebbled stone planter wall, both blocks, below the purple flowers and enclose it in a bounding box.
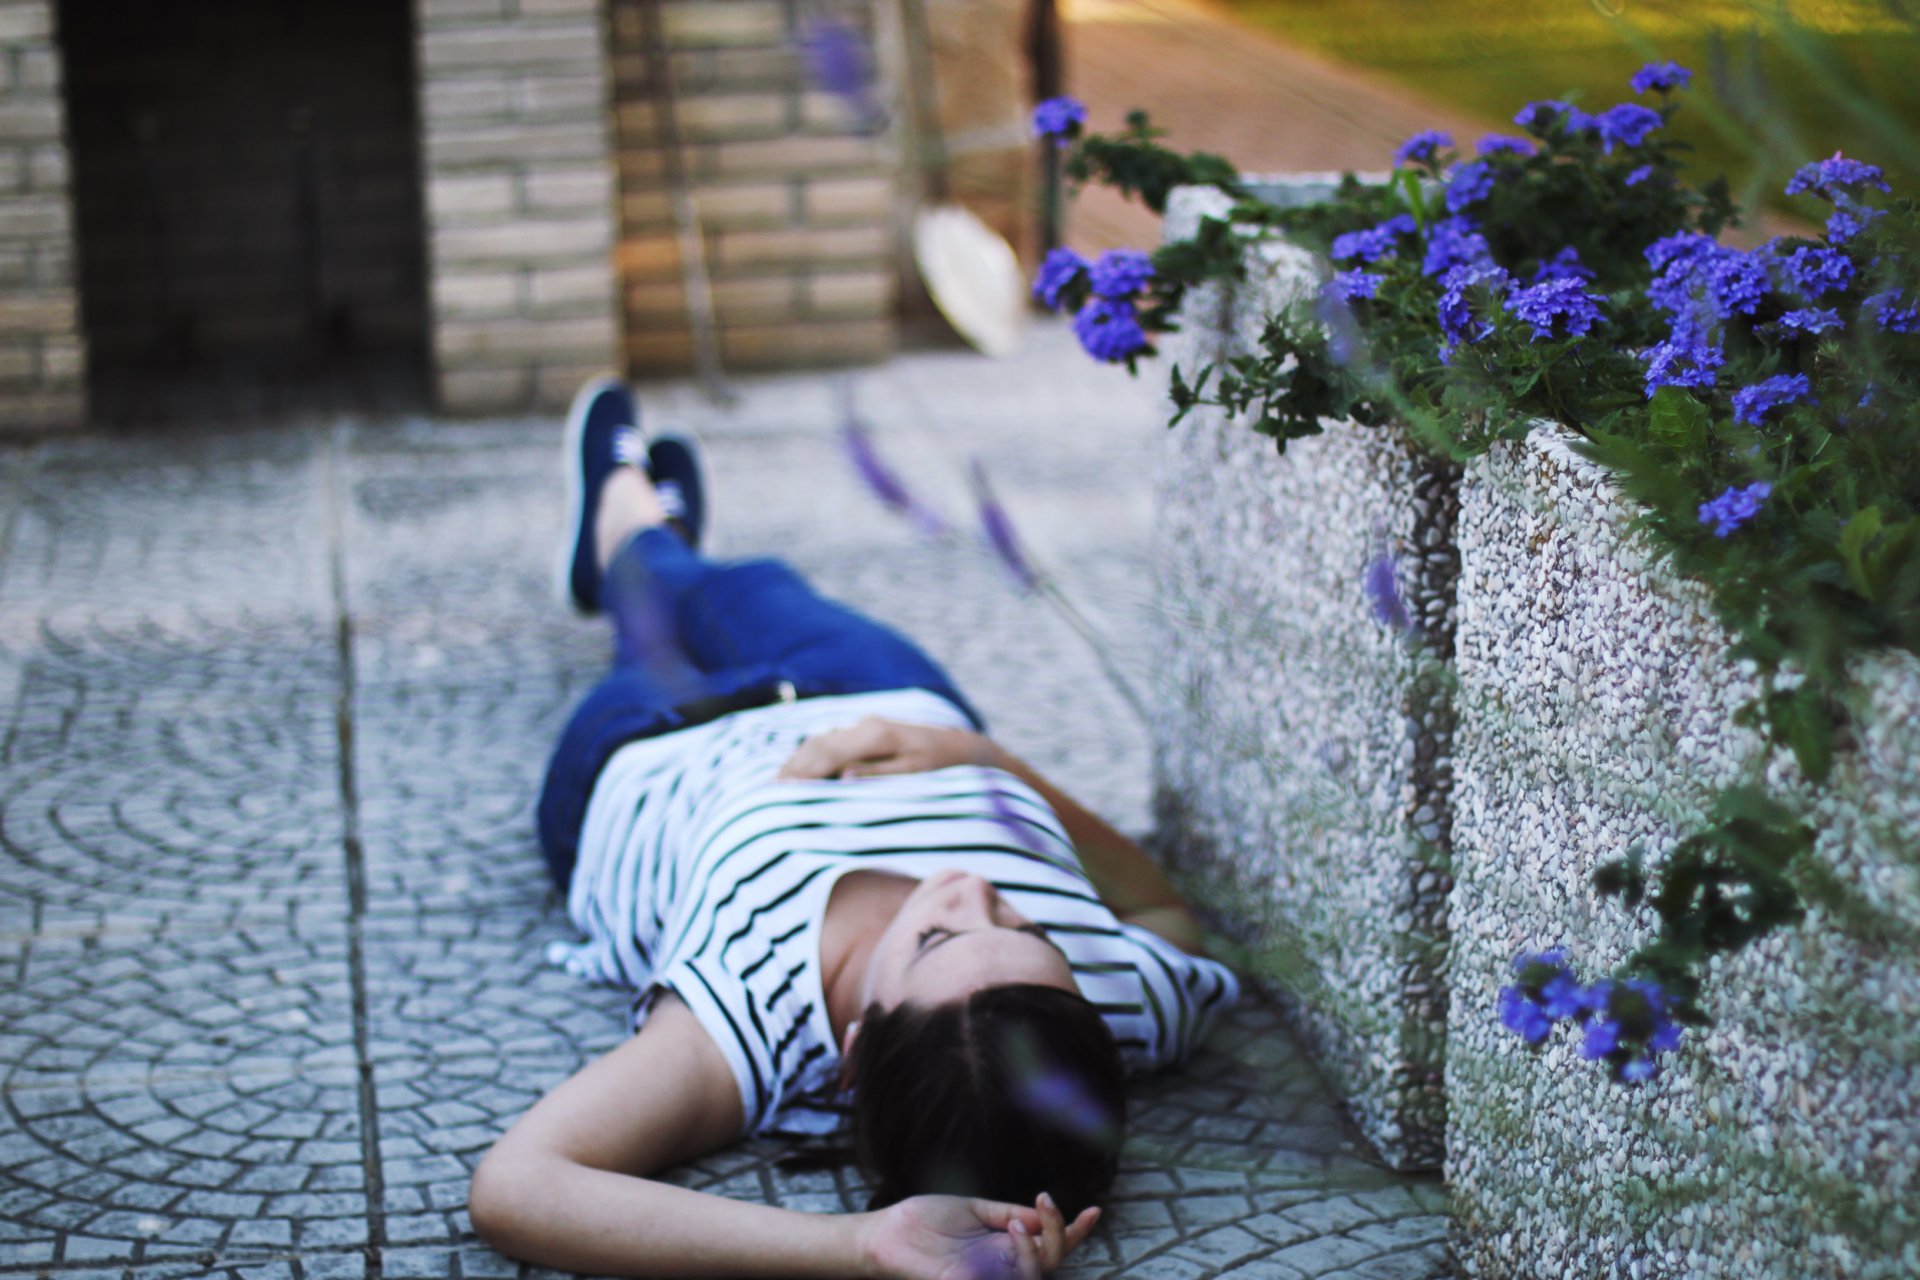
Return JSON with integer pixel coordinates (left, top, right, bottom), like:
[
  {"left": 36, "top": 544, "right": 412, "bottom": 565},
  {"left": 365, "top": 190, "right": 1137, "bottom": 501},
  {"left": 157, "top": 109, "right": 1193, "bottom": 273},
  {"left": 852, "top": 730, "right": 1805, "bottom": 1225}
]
[{"left": 1154, "top": 180, "right": 1920, "bottom": 1258}]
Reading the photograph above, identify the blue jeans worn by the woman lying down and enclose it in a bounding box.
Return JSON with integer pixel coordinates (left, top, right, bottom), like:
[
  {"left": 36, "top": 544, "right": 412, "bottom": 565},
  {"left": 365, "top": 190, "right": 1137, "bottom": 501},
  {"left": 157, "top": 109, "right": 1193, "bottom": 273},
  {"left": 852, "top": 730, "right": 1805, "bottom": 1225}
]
[{"left": 540, "top": 528, "right": 983, "bottom": 892}]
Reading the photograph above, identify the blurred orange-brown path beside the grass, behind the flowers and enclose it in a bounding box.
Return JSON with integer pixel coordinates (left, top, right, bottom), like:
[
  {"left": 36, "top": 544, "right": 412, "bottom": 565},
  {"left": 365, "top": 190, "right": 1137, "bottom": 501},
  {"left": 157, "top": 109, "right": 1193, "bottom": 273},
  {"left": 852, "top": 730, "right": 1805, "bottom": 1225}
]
[{"left": 1060, "top": 0, "right": 1500, "bottom": 253}]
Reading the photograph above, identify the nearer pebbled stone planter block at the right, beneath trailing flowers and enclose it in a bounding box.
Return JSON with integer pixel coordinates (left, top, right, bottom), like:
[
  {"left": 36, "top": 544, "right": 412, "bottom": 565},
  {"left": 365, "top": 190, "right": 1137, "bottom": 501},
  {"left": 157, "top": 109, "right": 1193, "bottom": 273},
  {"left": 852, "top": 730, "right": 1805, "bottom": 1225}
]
[{"left": 1446, "top": 432, "right": 1920, "bottom": 1280}]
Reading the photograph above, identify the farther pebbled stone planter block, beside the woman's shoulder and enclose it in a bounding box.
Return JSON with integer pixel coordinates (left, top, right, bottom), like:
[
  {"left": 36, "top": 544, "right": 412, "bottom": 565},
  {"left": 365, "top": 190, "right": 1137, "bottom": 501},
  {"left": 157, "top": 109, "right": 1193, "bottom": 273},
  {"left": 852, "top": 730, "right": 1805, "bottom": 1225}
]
[{"left": 1154, "top": 180, "right": 1453, "bottom": 1169}]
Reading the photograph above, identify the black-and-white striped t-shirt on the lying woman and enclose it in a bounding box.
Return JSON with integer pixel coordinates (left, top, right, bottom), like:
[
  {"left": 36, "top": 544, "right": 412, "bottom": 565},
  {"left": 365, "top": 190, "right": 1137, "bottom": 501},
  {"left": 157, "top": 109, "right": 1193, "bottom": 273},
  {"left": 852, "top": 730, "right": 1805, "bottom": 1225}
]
[{"left": 555, "top": 689, "right": 1238, "bottom": 1134}]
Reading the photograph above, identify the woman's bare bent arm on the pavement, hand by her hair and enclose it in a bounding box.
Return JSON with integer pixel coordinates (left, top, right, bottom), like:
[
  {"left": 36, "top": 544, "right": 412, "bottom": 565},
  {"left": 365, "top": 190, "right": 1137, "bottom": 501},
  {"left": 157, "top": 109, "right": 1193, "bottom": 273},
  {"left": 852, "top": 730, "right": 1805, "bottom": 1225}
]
[{"left": 468, "top": 996, "right": 1094, "bottom": 1280}]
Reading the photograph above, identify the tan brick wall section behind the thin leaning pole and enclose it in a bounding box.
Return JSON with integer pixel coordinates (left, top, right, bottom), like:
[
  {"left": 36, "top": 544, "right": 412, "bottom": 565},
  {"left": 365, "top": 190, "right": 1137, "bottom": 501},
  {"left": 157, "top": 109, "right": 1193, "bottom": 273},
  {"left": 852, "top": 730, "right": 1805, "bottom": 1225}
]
[{"left": 611, "top": 0, "right": 899, "bottom": 374}]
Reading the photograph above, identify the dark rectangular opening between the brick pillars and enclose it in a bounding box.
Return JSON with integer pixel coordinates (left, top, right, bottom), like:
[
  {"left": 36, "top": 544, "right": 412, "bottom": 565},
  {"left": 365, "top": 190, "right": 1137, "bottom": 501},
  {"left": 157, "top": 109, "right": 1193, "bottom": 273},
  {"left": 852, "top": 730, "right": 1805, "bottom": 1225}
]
[{"left": 60, "top": 0, "right": 428, "bottom": 422}]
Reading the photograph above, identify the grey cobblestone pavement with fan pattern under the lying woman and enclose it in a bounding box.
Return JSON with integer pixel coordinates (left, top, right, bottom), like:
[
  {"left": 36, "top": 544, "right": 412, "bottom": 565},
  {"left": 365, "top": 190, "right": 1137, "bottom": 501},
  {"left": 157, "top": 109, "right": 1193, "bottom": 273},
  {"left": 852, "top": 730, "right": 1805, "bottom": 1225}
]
[{"left": 0, "top": 328, "right": 1448, "bottom": 1280}]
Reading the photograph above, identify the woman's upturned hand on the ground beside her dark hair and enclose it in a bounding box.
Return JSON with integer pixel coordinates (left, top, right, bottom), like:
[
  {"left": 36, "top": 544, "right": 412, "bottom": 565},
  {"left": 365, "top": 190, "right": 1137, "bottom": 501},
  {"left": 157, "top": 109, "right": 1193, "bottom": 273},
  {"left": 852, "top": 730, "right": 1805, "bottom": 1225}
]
[{"left": 862, "top": 1194, "right": 1100, "bottom": 1280}]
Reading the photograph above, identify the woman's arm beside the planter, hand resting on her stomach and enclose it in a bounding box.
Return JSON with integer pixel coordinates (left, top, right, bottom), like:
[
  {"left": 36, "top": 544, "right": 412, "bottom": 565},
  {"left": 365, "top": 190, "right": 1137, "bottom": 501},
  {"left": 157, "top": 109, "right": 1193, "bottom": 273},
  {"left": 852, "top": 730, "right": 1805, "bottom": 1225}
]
[{"left": 780, "top": 716, "right": 1202, "bottom": 956}]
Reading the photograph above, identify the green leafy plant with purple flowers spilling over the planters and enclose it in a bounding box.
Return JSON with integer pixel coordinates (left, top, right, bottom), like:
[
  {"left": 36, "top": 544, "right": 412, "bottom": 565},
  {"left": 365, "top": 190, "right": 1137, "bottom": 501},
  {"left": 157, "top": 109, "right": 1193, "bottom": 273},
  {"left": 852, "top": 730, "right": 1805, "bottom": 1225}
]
[{"left": 1069, "top": 65, "right": 1920, "bottom": 1082}]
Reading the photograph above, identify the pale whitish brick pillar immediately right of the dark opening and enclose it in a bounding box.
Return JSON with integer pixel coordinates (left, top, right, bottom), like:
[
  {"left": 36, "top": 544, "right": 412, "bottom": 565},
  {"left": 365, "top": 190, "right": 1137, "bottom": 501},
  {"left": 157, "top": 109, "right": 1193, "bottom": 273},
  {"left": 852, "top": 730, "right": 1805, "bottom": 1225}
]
[{"left": 415, "top": 0, "right": 620, "bottom": 413}]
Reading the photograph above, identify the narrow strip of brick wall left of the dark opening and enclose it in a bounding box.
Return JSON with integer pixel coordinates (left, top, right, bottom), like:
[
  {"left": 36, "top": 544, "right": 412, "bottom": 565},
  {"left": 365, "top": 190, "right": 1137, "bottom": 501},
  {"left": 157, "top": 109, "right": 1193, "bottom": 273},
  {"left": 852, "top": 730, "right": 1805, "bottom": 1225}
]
[{"left": 0, "top": 0, "right": 86, "bottom": 430}]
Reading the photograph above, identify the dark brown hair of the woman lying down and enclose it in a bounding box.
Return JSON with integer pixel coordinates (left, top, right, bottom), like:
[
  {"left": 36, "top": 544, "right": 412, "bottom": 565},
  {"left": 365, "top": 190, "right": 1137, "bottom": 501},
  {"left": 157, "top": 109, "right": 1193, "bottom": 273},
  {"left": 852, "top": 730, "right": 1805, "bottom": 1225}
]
[{"left": 849, "top": 983, "right": 1127, "bottom": 1222}]
